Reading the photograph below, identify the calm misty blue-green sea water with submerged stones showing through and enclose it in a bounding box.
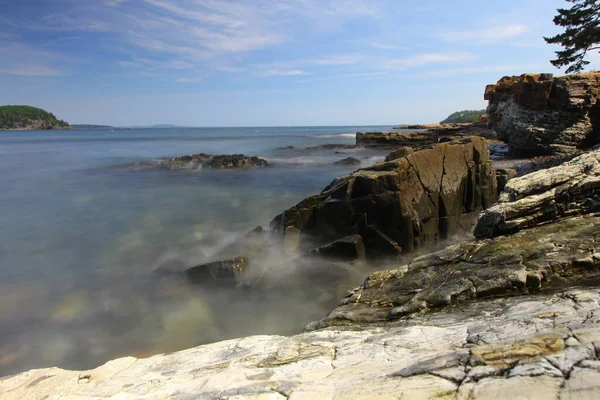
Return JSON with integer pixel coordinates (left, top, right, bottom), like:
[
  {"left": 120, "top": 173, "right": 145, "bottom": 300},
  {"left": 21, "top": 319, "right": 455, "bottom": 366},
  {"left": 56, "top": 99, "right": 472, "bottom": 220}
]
[{"left": 0, "top": 127, "right": 391, "bottom": 376}]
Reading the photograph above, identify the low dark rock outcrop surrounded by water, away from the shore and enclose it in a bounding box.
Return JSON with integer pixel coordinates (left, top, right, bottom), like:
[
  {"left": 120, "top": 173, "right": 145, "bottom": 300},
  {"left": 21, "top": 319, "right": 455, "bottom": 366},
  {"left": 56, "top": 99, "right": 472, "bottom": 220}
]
[{"left": 160, "top": 153, "right": 269, "bottom": 170}]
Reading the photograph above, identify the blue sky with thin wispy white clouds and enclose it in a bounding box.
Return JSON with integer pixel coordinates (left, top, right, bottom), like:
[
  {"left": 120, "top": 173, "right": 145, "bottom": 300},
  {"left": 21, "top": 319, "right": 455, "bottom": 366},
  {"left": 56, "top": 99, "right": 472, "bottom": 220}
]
[{"left": 0, "top": 0, "right": 600, "bottom": 126}]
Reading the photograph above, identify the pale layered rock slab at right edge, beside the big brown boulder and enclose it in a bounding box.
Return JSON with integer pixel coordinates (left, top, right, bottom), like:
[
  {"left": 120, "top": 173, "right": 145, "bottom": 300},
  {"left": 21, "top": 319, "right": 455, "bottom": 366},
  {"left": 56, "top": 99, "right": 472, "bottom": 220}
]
[{"left": 474, "top": 150, "right": 600, "bottom": 238}]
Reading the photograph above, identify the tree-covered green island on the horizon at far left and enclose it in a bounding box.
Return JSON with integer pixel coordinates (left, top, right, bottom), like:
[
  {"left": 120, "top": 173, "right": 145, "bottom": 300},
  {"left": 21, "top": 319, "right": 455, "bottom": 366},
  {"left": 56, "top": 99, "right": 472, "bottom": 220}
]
[{"left": 0, "top": 105, "right": 71, "bottom": 130}]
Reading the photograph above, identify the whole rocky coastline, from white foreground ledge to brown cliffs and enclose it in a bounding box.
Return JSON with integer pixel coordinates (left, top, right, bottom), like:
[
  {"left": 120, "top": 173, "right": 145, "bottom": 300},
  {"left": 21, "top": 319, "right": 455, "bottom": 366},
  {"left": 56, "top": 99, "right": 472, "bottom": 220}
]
[{"left": 0, "top": 73, "right": 600, "bottom": 400}]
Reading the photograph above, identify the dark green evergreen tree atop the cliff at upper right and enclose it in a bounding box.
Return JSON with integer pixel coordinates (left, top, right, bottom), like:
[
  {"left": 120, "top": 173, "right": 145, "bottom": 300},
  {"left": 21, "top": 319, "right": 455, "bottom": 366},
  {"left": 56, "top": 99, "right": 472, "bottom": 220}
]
[{"left": 544, "top": 0, "right": 600, "bottom": 74}]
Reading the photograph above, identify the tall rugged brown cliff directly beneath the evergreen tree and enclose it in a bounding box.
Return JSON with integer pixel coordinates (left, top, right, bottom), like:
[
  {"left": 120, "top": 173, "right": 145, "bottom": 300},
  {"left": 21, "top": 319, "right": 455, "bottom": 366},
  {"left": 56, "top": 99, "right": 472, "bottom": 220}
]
[{"left": 484, "top": 72, "right": 600, "bottom": 156}]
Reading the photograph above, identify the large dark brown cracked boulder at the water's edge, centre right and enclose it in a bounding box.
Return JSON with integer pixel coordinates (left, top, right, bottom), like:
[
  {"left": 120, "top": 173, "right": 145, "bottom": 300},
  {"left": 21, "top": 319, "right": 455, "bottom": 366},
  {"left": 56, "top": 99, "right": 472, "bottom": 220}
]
[{"left": 271, "top": 137, "right": 497, "bottom": 258}]
